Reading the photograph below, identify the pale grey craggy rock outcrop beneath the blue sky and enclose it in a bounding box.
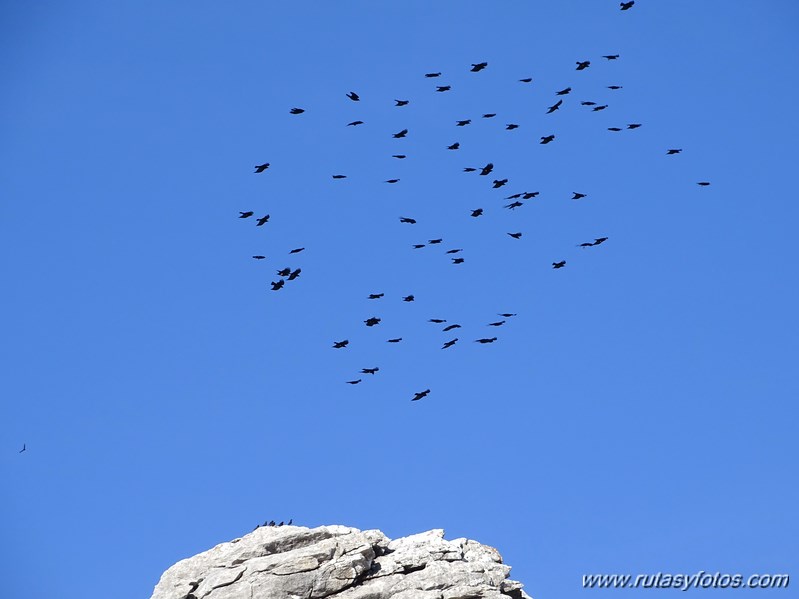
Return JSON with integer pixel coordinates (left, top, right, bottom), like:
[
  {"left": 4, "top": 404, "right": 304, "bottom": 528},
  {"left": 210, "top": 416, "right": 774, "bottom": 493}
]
[{"left": 151, "top": 526, "right": 530, "bottom": 599}]
